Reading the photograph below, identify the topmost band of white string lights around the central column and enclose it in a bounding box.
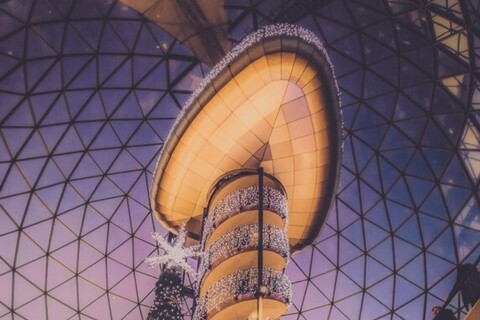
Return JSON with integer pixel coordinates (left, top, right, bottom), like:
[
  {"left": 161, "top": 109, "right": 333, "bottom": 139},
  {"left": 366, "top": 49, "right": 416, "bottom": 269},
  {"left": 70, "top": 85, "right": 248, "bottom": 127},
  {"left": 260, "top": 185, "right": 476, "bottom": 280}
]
[{"left": 201, "top": 186, "right": 288, "bottom": 248}]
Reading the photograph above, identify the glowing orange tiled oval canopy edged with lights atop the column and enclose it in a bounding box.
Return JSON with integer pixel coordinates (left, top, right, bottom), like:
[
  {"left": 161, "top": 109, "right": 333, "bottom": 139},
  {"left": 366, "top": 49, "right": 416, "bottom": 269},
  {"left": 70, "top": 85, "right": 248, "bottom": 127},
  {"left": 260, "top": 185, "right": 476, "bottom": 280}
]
[{"left": 151, "top": 25, "right": 341, "bottom": 249}]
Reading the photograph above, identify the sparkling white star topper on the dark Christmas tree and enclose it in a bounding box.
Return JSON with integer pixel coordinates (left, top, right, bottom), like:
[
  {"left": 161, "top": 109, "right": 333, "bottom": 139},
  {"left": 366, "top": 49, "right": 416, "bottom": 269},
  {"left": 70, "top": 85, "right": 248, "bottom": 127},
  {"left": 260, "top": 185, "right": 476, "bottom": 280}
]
[{"left": 145, "top": 226, "right": 201, "bottom": 280}]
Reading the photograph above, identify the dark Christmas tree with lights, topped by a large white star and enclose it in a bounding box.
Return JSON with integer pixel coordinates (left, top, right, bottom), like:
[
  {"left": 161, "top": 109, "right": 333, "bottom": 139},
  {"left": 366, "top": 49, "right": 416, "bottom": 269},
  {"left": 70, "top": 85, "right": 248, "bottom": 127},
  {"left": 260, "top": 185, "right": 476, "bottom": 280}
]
[{"left": 145, "top": 227, "right": 198, "bottom": 320}]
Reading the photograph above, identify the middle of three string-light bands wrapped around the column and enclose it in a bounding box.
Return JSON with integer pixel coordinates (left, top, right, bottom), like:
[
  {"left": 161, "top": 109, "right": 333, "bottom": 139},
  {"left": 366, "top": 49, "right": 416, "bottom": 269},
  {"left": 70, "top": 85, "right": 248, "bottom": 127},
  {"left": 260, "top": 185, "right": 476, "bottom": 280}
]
[{"left": 197, "top": 224, "right": 290, "bottom": 289}]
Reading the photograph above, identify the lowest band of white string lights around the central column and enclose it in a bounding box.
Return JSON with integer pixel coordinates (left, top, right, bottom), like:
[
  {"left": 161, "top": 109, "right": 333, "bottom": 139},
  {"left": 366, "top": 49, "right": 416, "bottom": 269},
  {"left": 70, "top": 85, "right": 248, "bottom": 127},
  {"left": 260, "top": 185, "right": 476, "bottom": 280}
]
[{"left": 193, "top": 268, "right": 292, "bottom": 320}]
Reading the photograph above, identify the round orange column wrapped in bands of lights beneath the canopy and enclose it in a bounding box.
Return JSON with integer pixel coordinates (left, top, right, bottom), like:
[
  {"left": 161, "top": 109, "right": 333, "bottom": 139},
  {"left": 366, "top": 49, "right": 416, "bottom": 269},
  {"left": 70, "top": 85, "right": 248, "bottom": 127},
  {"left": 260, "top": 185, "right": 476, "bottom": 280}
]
[{"left": 195, "top": 170, "right": 291, "bottom": 320}]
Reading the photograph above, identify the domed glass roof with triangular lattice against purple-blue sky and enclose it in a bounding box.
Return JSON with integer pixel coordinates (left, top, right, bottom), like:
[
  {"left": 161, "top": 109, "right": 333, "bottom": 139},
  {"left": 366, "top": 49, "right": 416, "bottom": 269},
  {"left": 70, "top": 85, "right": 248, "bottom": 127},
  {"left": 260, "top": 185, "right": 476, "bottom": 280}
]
[{"left": 0, "top": 0, "right": 480, "bottom": 320}]
